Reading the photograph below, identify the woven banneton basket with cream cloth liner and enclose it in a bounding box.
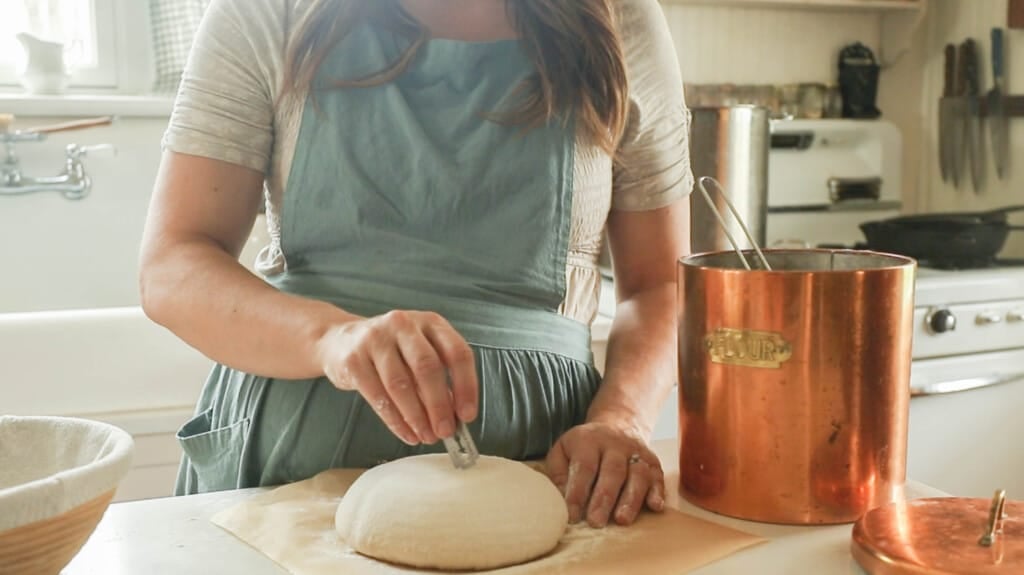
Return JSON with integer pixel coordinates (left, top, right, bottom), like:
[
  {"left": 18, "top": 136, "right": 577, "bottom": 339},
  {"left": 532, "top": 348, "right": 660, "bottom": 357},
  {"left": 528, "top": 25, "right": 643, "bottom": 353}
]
[{"left": 0, "top": 416, "right": 133, "bottom": 575}]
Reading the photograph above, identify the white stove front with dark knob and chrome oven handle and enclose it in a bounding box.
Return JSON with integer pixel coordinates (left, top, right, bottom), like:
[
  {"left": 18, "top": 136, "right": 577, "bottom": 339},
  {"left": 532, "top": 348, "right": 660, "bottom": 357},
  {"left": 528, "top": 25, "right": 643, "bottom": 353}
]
[{"left": 907, "top": 265, "right": 1024, "bottom": 498}]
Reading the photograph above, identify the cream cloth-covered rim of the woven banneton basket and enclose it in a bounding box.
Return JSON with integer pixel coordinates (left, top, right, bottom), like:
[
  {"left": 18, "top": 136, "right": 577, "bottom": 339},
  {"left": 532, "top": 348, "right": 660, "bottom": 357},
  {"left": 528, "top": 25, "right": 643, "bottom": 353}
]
[{"left": 0, "top": 415, "right": 134, "bottom": 533}]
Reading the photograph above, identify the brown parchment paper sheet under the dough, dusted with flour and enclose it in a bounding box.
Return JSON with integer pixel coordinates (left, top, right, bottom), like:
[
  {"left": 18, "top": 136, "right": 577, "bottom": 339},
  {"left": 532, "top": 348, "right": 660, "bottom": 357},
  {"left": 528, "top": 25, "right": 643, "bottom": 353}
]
[{"left": 212, "top": 470, "right": 764, "bottom": 575}]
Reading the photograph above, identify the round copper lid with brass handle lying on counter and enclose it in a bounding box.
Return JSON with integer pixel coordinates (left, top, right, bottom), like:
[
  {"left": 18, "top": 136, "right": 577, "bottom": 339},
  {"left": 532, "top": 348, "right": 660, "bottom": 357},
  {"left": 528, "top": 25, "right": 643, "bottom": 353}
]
[{"left": 851, "top": 490, "right": 1024, "bottom": 575}]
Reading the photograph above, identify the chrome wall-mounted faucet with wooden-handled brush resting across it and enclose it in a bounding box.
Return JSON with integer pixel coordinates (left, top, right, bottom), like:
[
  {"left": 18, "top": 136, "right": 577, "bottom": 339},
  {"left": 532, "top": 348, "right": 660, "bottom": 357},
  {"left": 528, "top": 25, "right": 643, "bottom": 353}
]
[{"left": 0, "top": 116, "right": 117, "bottom": 200}]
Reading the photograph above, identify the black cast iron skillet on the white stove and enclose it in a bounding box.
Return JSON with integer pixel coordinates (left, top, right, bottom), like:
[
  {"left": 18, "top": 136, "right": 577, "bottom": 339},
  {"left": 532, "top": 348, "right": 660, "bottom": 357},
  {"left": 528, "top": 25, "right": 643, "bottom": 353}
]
[{"left": 860, "top": 206, "right": 1024, "bottom": 267}]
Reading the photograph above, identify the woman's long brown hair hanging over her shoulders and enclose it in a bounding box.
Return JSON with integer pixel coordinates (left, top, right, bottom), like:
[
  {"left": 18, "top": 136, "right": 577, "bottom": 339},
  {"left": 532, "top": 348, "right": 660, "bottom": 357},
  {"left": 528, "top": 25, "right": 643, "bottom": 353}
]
[{"left": 284, "top": 0, "right": 629, "bottom": 156}]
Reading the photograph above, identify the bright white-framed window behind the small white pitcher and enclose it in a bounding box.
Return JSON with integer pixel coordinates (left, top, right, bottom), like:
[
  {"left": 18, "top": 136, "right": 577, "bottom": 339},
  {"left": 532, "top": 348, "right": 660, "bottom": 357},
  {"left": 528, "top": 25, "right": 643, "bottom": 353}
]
[{"left": 0, "top": 0, "right": 118, "bottom": 88}]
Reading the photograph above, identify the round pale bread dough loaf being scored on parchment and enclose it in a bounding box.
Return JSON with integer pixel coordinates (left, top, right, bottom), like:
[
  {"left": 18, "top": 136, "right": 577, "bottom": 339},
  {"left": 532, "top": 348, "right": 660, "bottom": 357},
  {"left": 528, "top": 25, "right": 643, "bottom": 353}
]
[{"left": 335, "top": 453, "right": 568, "bottom": 570}]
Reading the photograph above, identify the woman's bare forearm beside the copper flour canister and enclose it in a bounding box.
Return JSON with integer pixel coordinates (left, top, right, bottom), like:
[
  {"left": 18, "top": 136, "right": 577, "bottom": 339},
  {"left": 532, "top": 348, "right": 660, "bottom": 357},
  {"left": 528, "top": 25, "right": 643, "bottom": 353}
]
[{"left": 587, "top": 282, "right": 676, "bottom": 439}]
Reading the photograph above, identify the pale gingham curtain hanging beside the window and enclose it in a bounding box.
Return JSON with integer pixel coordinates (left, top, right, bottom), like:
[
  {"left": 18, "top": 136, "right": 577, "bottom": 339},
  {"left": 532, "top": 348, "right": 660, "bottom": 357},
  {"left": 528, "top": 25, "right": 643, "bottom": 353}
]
[{"left": 150, "top": 0, "right": 210, "bottom": 93}]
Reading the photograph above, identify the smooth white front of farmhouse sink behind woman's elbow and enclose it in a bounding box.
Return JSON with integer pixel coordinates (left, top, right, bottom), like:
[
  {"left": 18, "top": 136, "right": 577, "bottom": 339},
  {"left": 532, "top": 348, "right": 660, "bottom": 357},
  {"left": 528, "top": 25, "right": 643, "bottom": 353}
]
[{"left": 0, "top": 307, "right": 212, "bottom": 415}]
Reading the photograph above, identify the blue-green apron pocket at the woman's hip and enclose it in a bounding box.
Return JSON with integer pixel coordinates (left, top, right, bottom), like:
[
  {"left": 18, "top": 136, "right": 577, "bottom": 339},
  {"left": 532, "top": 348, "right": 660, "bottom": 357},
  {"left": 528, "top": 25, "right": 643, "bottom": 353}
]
[{"left": 177, "top": 407, "right": 251, "bottom": 492}]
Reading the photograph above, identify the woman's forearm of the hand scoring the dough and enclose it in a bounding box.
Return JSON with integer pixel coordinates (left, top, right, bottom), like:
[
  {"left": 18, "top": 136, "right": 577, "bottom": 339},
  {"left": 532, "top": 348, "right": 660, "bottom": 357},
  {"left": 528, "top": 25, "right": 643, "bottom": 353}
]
[{"left": 140, "top": 238, "right": 357, "bottom": 379}]
